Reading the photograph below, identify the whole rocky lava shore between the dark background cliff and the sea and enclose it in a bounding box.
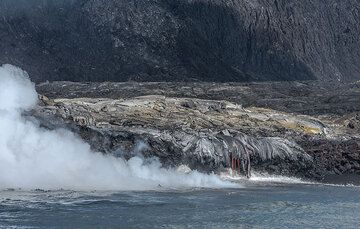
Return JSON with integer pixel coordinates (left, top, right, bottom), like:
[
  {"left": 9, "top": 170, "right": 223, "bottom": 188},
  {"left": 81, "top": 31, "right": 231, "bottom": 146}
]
[{"left": 32, "top": 82, "right": 360, "bottom": 183}]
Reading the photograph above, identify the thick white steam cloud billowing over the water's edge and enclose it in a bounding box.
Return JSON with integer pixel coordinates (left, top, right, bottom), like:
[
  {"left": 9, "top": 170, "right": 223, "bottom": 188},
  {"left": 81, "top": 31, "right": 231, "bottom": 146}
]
[{"left": 0, "top": 65, "right": 237, "bottom": 190}]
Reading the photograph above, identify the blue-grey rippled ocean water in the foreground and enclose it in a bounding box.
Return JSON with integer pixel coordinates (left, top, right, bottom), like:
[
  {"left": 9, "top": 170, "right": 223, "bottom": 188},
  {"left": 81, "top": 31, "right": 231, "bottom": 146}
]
[{"left": 0, "top": 179, "right": 360, "bottom": 228}]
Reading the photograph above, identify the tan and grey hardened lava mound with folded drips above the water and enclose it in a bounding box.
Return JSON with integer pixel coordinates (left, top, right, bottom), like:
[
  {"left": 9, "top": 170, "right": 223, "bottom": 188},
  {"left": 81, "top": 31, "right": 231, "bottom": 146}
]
[{"left": 34, "top": 89, "right": 360, "bottom": 179}]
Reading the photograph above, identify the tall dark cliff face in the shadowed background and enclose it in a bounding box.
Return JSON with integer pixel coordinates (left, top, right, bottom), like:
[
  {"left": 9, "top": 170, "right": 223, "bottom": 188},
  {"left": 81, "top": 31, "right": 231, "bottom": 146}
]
[{"left": 0, "top": 0, "right": 360, "bottom": 82}]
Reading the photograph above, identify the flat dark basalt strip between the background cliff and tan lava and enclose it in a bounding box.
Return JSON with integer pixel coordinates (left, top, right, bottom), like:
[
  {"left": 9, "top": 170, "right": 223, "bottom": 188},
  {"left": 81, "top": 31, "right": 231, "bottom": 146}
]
[{"left": 37, "top": 81, "right": 360, "bottom": 116}]
